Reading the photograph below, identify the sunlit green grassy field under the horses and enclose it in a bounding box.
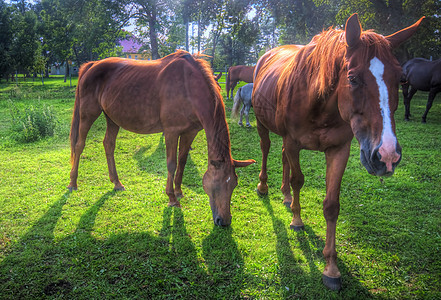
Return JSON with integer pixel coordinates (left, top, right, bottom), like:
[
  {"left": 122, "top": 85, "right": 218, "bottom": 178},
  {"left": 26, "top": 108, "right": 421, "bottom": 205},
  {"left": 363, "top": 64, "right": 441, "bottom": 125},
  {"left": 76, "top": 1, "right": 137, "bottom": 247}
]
[{"left": 0, "top": 78, "right": 441, "bottom": 299}]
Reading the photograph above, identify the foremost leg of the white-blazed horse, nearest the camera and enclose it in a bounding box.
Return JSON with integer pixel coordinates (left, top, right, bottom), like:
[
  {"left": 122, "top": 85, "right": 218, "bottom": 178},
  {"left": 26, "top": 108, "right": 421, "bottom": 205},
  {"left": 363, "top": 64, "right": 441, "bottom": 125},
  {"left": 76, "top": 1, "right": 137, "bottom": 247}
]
[{"left": 323, "top": 142, "right": 350, "bottom": 290}]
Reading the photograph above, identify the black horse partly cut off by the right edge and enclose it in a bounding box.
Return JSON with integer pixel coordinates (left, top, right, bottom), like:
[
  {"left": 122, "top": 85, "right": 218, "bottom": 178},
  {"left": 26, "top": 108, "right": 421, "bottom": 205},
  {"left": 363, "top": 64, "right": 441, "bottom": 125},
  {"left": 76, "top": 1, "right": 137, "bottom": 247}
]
[{"left": 401, "top": 57, "right": 441, "bottom": 123}]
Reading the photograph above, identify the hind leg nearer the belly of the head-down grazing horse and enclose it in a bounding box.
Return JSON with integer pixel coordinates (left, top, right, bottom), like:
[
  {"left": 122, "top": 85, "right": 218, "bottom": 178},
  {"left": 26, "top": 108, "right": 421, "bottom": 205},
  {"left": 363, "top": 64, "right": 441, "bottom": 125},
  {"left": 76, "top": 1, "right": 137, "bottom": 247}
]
[{"left": 103, "top": 115, "right": 125, "bottom": 191}]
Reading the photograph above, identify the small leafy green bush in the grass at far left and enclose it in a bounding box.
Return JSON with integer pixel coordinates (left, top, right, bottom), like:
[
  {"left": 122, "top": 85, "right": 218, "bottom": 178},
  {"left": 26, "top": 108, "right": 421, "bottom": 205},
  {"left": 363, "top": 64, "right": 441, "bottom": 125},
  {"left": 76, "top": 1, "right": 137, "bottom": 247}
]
[{"left": 10, "top": 101, "right": 57, "bottom": 143}]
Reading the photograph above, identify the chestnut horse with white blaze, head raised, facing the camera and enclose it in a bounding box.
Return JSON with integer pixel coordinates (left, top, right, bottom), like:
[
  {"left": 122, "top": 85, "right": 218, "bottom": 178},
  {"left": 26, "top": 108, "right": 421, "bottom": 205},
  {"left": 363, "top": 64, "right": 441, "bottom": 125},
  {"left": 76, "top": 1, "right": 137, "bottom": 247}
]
[{"left": 252, "top": 14, "right": 421, "bottom": 289}]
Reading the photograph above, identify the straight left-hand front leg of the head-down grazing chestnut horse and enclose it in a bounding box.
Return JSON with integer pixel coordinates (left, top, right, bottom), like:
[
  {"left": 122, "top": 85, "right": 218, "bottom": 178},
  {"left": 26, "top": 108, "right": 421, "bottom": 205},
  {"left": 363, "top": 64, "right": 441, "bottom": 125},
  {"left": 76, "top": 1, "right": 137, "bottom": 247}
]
[{"left": 165, "top": 132, "right": 181, "bottom": 207}]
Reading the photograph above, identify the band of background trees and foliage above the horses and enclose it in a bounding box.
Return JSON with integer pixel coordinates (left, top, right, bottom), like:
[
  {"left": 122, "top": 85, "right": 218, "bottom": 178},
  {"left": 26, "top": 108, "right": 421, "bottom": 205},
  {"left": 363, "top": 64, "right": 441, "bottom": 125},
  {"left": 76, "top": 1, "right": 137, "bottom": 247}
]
[{"left": 0, "top": 0, "right": 441, "bottom": 77}]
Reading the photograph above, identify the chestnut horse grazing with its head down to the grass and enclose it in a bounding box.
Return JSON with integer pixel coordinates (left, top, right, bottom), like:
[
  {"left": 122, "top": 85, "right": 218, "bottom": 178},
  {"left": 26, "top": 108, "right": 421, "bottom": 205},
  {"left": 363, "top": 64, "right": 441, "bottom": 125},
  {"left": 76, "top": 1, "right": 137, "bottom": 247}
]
[{"left": 68, "top": 51, "right": 254, "bottom": 226}]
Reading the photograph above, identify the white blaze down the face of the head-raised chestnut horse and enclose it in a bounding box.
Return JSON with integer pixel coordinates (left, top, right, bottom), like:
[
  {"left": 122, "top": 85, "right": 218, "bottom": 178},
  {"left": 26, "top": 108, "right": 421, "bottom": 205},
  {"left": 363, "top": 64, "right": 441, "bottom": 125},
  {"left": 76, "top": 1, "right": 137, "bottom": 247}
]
[{"left": 369, "top": 57, "right": 400, "bottom": 172}]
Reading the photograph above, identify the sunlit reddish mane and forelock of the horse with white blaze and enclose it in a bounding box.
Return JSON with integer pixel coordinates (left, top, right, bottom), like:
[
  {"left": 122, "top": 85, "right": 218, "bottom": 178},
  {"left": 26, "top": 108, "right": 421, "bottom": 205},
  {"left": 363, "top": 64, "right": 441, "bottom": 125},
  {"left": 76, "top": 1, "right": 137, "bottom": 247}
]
[{"left": 279, "top": 29, "right": 394, "bottom": 97}]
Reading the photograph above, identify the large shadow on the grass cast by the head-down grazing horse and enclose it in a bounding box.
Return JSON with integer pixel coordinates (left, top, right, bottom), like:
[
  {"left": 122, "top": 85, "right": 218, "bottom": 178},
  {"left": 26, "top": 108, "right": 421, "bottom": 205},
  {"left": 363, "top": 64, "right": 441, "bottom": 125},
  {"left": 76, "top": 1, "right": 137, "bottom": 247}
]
[{"left": 0, "top": 191, "right": 243, "bottom": 299}]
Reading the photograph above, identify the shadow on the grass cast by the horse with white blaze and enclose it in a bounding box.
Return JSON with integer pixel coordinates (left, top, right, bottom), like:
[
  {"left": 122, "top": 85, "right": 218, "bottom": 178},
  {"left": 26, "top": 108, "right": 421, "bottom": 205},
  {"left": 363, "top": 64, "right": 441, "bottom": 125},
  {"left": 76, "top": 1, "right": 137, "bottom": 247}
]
[{"left": 262, "top": 196, "right": 372, "bottom": 299}]
